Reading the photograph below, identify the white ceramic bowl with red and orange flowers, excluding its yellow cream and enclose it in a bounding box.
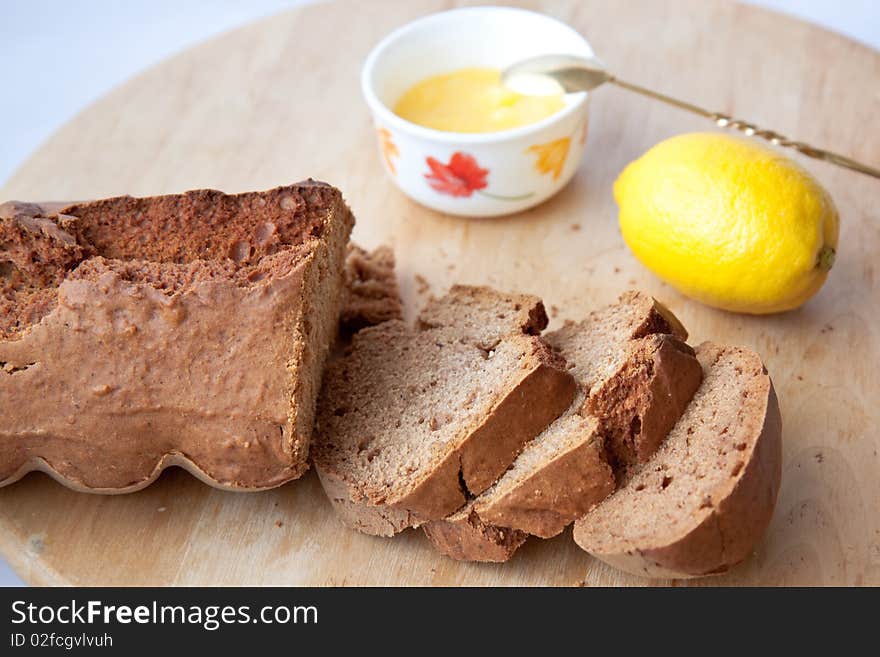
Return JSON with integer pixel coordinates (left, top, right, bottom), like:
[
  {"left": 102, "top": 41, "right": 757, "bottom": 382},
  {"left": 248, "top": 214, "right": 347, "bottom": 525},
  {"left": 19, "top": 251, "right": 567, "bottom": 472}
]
[{"left": 361, "top": 7, "right": 593, "bottom": 217}]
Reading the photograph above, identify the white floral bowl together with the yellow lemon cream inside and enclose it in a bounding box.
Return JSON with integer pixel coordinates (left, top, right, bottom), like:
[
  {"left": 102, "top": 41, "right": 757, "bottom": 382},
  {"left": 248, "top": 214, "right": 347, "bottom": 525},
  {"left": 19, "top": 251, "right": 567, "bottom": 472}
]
[{"left": 361, "top": 7, "right": 593, "bottom": 217}]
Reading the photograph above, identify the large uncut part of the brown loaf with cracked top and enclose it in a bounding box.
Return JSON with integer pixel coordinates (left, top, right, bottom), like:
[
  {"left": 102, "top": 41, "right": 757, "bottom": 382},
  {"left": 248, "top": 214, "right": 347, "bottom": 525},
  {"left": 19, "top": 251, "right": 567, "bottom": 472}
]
[{"left": 0, "top": 181, "right": 354, "bottom": 493}]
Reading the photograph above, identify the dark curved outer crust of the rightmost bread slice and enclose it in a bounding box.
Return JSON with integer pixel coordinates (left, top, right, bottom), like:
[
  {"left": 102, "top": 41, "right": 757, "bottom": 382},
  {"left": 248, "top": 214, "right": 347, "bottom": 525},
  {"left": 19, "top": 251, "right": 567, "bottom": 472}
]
[{"left": 574, "top": 345, "right": 782, "bottom": 579}]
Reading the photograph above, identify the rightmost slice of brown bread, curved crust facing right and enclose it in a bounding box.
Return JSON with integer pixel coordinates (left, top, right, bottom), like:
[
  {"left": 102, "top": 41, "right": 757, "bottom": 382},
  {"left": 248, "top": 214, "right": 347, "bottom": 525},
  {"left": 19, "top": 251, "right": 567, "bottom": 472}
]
[{"left": 574, "top": 343, "right": 782, "bottom": 577}]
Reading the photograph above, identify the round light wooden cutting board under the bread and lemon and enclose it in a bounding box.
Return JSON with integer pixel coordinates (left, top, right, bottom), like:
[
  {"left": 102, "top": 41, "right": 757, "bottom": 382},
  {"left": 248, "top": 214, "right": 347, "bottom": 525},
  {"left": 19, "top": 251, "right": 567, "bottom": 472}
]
[{"left": 0, "top": 0, "right": 880, "bottom": 585}]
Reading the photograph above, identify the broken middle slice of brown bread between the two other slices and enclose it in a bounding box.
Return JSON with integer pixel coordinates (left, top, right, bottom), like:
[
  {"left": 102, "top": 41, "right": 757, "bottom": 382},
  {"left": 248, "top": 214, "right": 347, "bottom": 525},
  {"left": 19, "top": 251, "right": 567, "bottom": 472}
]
[{"left": 425, "top": 292, "right": 702, "bottom": 561}]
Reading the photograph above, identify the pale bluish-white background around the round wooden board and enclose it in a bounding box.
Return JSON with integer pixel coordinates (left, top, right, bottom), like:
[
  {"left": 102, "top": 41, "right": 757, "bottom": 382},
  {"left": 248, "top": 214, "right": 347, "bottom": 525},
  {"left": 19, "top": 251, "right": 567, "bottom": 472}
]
[{"left": 0, "top": 0, "right": 880, "bottom": 586}]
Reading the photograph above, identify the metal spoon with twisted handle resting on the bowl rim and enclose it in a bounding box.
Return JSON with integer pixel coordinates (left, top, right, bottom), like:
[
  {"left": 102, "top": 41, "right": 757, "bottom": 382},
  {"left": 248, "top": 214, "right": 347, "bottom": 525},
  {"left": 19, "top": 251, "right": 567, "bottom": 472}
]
[{"left": 501, "top": 55, "right": 880, "bottom": 178}]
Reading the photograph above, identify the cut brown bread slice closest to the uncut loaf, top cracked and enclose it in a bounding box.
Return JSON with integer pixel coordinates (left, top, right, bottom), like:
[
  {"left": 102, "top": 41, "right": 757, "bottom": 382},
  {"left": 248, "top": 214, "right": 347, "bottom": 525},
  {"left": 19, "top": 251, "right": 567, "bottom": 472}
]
[{"left": 313, "top": 286, "right": 576, "bottom": 535}]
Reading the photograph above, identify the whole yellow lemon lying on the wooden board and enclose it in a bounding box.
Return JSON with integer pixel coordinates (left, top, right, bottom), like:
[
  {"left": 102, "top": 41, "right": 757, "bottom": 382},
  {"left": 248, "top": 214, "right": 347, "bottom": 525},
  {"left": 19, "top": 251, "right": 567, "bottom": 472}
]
[{"left": 614, "top": 133, "right": 838, "bottom": 314}]
